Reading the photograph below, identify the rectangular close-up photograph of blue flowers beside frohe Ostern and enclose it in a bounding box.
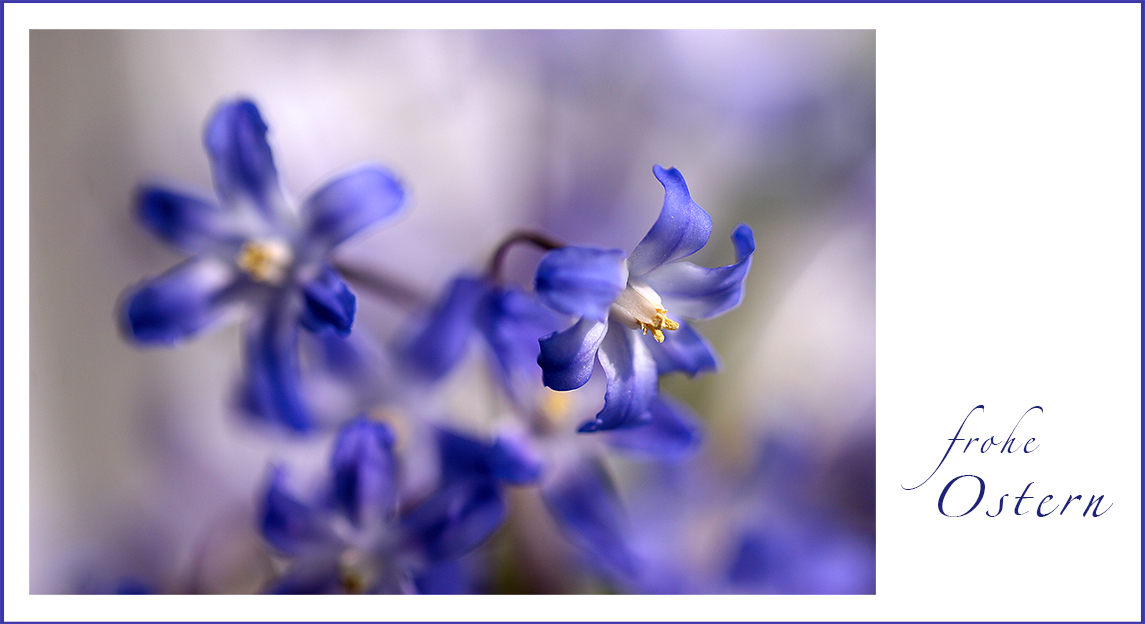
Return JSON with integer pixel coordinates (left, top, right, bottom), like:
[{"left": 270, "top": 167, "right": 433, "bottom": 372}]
[{"left": 31, "top": 28, "right": 874, "bottom": 595}]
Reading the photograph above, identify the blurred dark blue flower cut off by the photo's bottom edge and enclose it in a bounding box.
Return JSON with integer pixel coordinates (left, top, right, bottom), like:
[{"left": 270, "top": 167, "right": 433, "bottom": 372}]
[{"left": 260, "top": 418, "right": 505, "bottom": 593}]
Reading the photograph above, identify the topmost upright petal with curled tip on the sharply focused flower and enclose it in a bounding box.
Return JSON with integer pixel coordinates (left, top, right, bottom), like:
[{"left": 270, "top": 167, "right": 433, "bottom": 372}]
[{"left": 629, "top": 165, "right": 712, "bottom": 277}]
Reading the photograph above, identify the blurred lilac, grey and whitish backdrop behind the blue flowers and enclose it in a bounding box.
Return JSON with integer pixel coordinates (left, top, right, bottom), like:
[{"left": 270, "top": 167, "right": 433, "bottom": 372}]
[{"left": 30, "top": 31, "right": 875, "bottom": 593}]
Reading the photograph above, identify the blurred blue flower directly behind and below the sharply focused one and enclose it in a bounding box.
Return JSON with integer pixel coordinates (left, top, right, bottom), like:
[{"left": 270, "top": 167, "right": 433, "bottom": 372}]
[{"left": 393, "top": 267, "right": 701, "bottom": 577}]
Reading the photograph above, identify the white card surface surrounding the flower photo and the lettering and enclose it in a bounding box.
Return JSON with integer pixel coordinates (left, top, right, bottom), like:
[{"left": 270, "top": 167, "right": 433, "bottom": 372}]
[{"left": 5, "top": 5, "right": 1140, "bottom": 621}]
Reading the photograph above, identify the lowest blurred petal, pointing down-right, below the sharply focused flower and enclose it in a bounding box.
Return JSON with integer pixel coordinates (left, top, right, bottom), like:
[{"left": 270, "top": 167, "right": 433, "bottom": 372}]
[{"left": 540, "top": 461, "right": 635, "bottom": 574}]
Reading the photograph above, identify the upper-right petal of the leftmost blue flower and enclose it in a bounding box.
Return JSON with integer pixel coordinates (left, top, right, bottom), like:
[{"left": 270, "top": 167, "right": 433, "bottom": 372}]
[{"left": 302, "top": 165, "right": 405, "bottom": 251}]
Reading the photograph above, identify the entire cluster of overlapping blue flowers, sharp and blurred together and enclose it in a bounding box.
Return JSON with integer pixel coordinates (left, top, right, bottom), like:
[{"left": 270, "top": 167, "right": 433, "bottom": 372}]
[{"left": 120, "top": 100, "right": 755, "bottom": 593}]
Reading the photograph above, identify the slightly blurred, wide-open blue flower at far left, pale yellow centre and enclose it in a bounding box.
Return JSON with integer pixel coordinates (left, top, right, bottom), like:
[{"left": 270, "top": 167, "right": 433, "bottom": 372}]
[{"left": 121, "top": 100, "right": 405, "bottom": 431}]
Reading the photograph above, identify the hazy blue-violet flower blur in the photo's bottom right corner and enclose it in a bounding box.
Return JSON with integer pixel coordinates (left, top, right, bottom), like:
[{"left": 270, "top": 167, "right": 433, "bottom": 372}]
[{"left": 603, "top": 432, "right": 875, "bottom": 594}]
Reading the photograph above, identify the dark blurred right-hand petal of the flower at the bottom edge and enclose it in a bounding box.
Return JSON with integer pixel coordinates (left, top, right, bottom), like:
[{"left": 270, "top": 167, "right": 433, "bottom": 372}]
[{"left": 402, "top": 479, "right": 505, "bottom": 562}]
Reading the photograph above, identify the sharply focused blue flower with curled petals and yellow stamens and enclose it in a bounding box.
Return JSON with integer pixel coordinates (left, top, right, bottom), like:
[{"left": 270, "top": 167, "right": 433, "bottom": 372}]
[{"left": 536, "top": 165, "right": 756, "bottom": 432}]
